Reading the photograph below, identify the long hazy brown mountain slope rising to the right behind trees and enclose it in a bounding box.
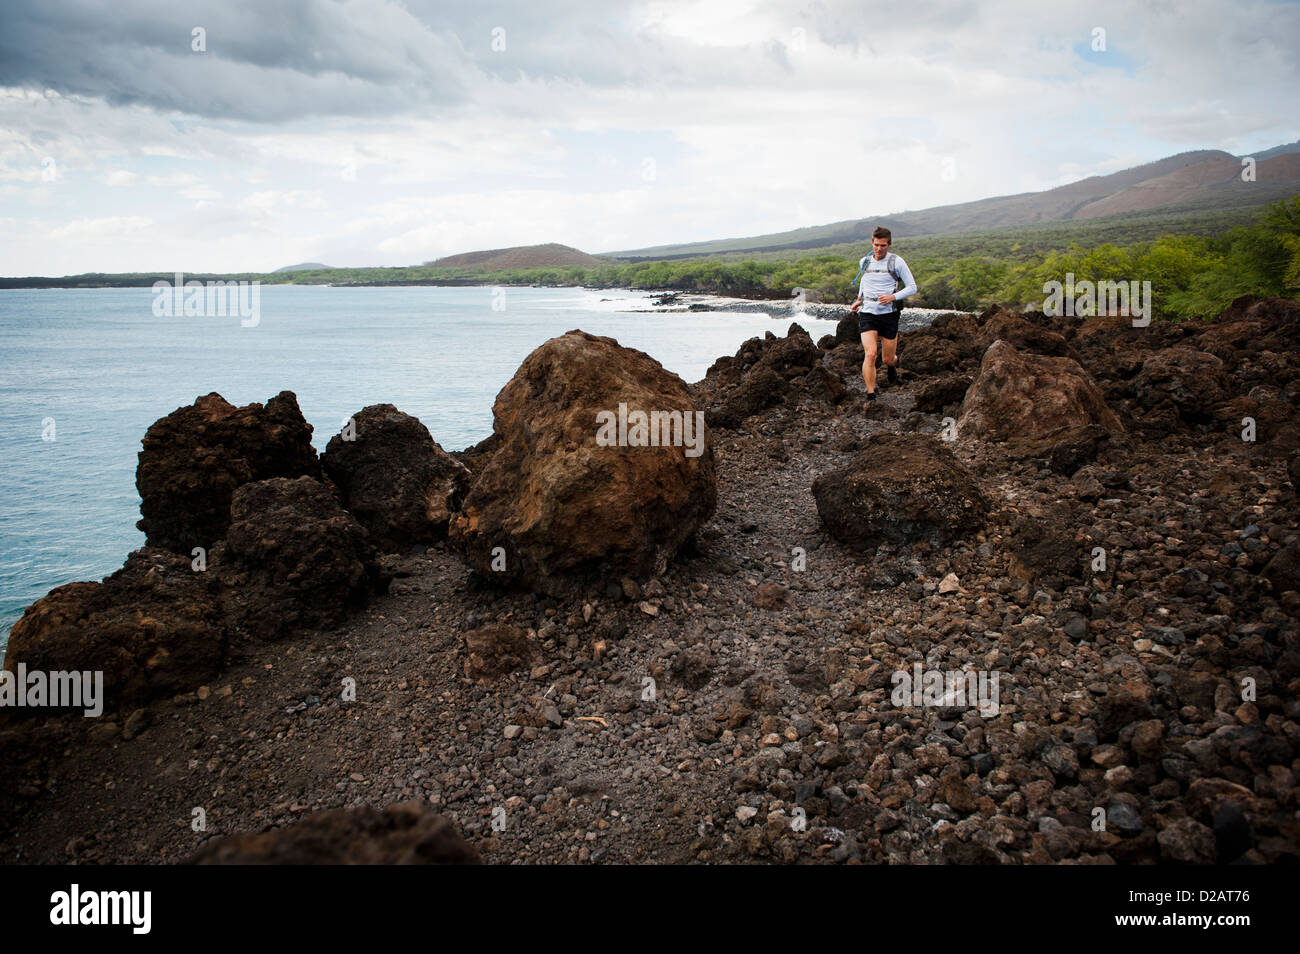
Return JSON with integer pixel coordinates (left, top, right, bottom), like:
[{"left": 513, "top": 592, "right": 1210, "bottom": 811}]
[{"left": 605, "top": 140, "right": 1300, "bottom": 259}]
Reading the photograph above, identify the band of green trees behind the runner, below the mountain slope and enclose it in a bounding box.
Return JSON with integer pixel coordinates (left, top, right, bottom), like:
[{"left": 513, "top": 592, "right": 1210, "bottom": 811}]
[{"left": 277, "top": 195, "right": 1300, "bottom": 317}]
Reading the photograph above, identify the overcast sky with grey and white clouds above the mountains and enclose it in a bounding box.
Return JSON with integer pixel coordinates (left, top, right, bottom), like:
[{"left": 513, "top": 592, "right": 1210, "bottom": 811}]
[{"left": 0, "top": 0, "right": 1300, "bottom": 276}]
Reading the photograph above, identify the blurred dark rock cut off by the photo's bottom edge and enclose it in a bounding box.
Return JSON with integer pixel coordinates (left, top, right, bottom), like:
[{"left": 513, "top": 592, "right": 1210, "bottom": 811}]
[{"left": 186, "top": 799, "right": 481, "bottom": 864}]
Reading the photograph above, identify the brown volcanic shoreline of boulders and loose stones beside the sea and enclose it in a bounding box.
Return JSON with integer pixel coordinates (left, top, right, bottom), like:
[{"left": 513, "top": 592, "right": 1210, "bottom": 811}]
[{"left": 0, "top": 299, "right": 1300, "bottom": 864}]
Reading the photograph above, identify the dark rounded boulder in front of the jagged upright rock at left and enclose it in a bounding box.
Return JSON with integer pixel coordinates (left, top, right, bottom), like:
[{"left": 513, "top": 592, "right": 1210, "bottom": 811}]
[{"left": 212, "top": 477, "right": 391, "bottom": 639}]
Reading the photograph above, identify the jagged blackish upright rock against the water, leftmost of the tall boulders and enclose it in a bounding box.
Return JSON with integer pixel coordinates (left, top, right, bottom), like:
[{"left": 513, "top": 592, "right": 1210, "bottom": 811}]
[{"left": 135, "top": 391, "right": 321, "bottom": 555}]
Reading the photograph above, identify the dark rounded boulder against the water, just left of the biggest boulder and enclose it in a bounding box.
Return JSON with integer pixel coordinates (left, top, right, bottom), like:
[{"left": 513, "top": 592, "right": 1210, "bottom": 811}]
[{"left": 321, "top": 404, "right": 471, "bottom": 552}]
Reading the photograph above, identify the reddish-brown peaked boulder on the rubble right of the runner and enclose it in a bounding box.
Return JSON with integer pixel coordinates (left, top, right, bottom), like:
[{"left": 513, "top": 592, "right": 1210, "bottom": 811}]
[{"left": 958, "top": 339, "right": 1123, "bottom": 441}]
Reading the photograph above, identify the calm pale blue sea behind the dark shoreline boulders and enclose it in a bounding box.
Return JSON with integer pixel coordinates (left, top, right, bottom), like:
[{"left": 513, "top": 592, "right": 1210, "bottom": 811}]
[{"left": 0, "top": 286, "right": 835, "bottom": 649}]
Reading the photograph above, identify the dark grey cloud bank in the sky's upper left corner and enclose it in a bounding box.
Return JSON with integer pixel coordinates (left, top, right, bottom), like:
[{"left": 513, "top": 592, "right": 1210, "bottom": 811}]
[{"left": 0, "top": 0, "right": 473, "bottom": 122}]
